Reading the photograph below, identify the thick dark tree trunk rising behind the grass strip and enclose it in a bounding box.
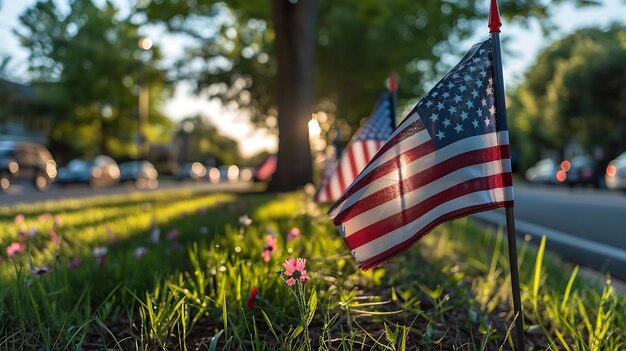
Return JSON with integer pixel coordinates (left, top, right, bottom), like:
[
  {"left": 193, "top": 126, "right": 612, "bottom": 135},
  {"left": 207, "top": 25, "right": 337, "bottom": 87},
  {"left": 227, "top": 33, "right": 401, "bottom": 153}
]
[{"left": 268, "top": 0, "right": 317, "bottom": 191}]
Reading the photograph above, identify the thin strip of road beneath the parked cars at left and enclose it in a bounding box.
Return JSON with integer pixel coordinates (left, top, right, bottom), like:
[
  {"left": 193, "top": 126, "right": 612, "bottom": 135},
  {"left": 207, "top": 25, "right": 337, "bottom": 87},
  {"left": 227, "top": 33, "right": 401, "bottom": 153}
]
[{"left": 0, "top": 181, "right": 253, "bottom": 206}]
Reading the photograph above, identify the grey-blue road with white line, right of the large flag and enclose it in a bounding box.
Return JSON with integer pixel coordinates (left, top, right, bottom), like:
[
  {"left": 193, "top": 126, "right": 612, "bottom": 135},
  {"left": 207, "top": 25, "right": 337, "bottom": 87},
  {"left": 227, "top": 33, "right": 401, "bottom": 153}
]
[{"left": 475, "top": 185, "right": 626, "bottom": 279}]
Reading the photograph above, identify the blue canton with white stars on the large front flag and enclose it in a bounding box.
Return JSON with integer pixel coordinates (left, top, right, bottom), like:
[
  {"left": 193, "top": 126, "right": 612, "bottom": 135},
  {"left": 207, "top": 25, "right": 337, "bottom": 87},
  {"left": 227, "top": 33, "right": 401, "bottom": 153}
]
[{"left": 416, "top": 40, "right": 502, "bottom": 149}]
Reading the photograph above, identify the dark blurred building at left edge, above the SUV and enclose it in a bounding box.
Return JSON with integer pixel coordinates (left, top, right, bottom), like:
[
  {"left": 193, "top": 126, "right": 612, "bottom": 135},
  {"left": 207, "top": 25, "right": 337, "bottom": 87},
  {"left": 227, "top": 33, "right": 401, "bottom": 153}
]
[{"left": 0, "top": 79, "right": 50, "bottom": 144}]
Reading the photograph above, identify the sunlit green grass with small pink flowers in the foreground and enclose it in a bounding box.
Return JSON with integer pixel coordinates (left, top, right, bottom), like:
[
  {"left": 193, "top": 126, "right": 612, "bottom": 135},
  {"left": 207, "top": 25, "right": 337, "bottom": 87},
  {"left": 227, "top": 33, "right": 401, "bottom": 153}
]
[{"left": 0, "top": 191, "right": 626, "bottom": 350}]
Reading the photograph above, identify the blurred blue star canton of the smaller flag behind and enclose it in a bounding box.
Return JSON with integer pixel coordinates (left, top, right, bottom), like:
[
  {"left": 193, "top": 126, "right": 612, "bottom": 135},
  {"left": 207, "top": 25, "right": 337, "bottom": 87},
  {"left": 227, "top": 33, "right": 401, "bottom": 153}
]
[{"left": 356, "top": 92, "right": 395, "bottom": 141}]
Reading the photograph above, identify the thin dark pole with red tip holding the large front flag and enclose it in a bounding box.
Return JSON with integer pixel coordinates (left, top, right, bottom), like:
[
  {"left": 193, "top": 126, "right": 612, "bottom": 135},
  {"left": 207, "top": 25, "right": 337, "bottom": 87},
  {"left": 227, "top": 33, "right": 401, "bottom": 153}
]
[{"left": 489, "top": 0, "right": 526, "bottom": 350}]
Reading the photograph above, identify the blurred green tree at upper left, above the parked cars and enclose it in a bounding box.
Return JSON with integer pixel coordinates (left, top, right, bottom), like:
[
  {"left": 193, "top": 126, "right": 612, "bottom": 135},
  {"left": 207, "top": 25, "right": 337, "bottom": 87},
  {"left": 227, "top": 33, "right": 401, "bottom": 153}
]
[{"left": 18, "top": 0, "right": 171, "bottom": 161}]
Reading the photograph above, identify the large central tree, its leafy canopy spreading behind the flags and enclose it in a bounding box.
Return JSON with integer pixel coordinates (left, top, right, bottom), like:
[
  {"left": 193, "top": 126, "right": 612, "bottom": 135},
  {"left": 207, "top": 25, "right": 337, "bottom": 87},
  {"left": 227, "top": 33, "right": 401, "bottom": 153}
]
[{"left": 143, "top": 0, "right": 594, "bottom": 190}]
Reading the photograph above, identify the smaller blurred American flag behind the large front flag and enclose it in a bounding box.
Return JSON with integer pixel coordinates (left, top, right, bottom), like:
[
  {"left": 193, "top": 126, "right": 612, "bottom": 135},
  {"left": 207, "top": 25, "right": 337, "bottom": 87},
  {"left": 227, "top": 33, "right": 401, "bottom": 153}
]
[{"left": 314, "top": 92, "right": 395, "bottom": 203}]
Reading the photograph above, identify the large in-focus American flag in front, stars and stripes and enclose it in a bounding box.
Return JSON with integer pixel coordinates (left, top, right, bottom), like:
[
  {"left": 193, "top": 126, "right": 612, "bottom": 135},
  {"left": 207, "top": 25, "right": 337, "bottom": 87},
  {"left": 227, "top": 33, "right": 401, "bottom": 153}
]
[{"left": 329, "top": 40, "right": 513, "bottom": 269}]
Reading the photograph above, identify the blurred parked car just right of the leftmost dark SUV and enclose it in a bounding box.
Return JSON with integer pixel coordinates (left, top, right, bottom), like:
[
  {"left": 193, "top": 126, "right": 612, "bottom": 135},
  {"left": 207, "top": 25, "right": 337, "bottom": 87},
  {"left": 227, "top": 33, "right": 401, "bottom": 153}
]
[{"left": 57, "top": 155, "right": 120, "bottom": 187}]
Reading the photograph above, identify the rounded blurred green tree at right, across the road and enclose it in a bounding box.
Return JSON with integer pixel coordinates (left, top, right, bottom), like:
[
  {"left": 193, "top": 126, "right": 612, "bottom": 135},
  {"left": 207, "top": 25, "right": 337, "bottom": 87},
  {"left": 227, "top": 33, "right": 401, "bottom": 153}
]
[{"left": 511, "top": 26, "right": 626, "bottom": 168}]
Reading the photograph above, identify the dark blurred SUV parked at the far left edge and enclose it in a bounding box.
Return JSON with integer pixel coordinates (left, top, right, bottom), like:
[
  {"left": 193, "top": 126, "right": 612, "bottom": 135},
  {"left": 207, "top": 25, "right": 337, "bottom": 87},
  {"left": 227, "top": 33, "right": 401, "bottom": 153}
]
[{"left": 0, "top": 140, "right": 57, "bottom": 191}]
